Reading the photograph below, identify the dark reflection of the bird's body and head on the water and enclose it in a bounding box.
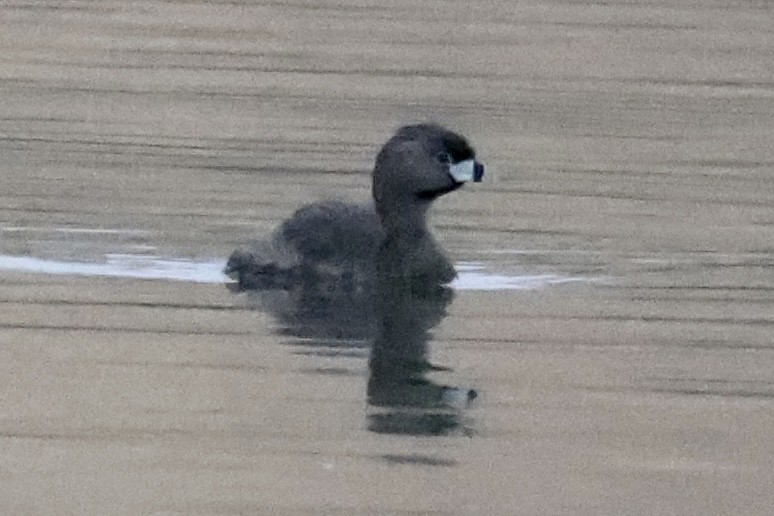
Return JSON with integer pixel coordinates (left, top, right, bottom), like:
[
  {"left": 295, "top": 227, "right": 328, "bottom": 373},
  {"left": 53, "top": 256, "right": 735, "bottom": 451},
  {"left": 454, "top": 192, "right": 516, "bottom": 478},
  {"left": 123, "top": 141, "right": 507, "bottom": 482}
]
[{"left": 242, "top": 274, "right": 477, "bottom": 436}]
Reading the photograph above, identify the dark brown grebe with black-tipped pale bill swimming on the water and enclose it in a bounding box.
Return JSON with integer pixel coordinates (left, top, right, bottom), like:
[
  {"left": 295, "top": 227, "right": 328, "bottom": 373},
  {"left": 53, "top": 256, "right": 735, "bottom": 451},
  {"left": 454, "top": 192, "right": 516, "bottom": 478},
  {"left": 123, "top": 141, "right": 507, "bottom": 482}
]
[{"left": 225, "top": 124, "right": 484, "bottom": 291}]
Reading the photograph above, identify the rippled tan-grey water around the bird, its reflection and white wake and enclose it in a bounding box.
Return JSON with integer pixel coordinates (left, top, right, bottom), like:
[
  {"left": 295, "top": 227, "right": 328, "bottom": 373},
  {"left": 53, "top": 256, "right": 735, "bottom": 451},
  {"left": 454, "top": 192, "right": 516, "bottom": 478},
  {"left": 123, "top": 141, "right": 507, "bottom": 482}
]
[{"left": 0, "top": 0, "right": 774, "bottom": 515}]
